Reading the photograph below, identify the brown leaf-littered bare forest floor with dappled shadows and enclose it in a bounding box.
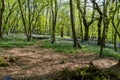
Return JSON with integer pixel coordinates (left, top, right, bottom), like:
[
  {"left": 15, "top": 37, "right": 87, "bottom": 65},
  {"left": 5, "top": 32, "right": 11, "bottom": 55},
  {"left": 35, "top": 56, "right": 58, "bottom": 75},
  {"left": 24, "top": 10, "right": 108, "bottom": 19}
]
[{"left": 0, "top": 41, "right": 120, "bottom": 80}]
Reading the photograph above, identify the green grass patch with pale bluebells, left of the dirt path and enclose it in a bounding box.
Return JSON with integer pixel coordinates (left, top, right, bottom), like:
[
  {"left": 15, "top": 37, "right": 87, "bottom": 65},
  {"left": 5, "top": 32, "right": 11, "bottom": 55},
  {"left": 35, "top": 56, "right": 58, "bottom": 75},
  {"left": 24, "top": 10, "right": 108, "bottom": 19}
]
[{"left": 0, "top": 34, "right": 35, "bottom": 48}]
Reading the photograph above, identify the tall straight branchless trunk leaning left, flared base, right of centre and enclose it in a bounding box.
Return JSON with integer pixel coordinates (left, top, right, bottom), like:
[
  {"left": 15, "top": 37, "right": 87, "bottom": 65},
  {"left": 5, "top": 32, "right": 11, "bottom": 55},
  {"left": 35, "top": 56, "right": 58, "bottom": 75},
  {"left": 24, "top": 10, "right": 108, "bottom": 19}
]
[{"left": 70, "top": 0, "right": 81, "bottom": 48}]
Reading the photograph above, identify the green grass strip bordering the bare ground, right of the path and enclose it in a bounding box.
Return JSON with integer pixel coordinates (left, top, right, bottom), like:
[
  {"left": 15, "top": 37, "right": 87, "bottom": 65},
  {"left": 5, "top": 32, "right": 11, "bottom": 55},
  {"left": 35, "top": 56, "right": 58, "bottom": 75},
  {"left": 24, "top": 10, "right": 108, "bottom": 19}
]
[{"left": 42, "top": 40, "right": 120, "bottom": 59}]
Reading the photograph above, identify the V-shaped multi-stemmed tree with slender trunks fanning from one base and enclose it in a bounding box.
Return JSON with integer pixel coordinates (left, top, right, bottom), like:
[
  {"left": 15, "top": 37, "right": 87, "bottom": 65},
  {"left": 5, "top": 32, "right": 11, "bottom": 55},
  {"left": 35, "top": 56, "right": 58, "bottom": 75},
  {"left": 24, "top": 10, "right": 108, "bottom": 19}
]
[{"left": 18, "top": 0, "right": 46, "bottom": 41}]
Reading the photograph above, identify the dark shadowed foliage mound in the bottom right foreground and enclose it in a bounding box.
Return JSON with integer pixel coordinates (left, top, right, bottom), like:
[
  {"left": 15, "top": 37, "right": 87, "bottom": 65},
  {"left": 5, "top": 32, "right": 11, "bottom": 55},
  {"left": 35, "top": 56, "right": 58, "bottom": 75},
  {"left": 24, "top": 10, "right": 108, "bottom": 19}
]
[{"left": 53, "top": 67, "right": 119, "bottom": 80}]
